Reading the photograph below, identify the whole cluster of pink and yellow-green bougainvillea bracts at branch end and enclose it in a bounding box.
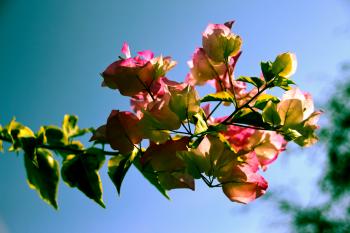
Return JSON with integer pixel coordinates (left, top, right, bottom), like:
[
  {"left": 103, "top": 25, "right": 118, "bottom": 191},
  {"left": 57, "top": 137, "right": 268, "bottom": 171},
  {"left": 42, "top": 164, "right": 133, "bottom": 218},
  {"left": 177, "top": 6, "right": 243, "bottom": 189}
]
[{"left": 91, "top": 22, "right": 320, "bottom": 203}]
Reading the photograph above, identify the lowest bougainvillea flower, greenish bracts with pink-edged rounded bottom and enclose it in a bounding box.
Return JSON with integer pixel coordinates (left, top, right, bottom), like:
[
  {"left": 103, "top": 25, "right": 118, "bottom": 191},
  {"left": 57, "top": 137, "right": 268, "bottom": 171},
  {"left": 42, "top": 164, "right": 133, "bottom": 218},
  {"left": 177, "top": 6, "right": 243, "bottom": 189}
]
[{"left": 190, "top": 135, "right": 267, "bottom": 203}]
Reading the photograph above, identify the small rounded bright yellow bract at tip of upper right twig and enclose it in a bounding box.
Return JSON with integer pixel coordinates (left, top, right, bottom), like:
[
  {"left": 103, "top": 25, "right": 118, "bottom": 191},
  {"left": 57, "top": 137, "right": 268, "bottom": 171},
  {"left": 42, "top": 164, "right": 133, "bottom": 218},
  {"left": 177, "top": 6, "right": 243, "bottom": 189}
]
[{"left": 272, "top": 52, "right": 297, "bottom": 78}]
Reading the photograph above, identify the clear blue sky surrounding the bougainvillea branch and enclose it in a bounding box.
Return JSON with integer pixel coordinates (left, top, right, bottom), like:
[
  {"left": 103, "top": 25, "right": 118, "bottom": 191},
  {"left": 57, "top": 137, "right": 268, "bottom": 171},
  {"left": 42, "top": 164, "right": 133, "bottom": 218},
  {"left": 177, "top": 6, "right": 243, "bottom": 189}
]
[{"left": 0, "top": 0, "right": 350, "bottom": 233}]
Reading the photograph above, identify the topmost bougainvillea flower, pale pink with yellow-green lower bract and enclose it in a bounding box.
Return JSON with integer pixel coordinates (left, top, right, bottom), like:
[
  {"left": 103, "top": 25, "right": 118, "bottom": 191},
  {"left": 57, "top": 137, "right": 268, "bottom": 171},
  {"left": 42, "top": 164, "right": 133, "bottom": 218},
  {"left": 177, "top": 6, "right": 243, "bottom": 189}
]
[{"left": 202, "top": 24, "right": 242, "bottom": 62}]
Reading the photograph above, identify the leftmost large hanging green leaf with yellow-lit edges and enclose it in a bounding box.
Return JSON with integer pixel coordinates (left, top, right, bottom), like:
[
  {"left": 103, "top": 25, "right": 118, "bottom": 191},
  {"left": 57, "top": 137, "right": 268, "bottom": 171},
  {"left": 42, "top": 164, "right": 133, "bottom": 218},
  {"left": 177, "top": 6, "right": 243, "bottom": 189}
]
[{"left": 24, "top": 149, "right": 59, "bottom": 209}]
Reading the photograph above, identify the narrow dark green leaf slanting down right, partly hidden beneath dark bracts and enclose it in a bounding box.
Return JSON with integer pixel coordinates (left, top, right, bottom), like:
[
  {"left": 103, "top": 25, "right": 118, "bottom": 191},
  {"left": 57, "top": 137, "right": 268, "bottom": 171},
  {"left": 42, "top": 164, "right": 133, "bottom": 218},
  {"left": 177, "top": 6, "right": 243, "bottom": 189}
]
[{"left": 133, "top": 156, "right": 170, "bottom": 200}]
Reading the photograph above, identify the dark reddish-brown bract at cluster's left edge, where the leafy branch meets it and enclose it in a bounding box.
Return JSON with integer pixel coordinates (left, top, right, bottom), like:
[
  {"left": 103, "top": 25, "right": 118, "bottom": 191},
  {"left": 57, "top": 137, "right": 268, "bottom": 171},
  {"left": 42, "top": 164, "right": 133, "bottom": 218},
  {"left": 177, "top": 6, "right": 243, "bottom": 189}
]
[{"left": 106, "top": 110, "right": 142, "bottom": 154}]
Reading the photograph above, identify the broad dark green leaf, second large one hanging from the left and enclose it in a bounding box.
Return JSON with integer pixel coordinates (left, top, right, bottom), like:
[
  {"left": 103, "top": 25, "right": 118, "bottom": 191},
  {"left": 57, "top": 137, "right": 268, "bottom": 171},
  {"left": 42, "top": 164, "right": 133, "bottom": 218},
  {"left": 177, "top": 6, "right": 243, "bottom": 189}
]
[{"left": 61, "top": 148, "right": 105, "bottom": 208}]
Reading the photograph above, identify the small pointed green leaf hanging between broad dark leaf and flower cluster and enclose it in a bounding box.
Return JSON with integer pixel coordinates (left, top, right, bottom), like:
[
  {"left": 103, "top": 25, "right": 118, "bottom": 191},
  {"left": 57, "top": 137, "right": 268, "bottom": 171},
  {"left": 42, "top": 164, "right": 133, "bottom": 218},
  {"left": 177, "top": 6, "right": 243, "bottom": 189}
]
[{"left": 108, "top": 148, "right": 138, "bottom": 195}]
